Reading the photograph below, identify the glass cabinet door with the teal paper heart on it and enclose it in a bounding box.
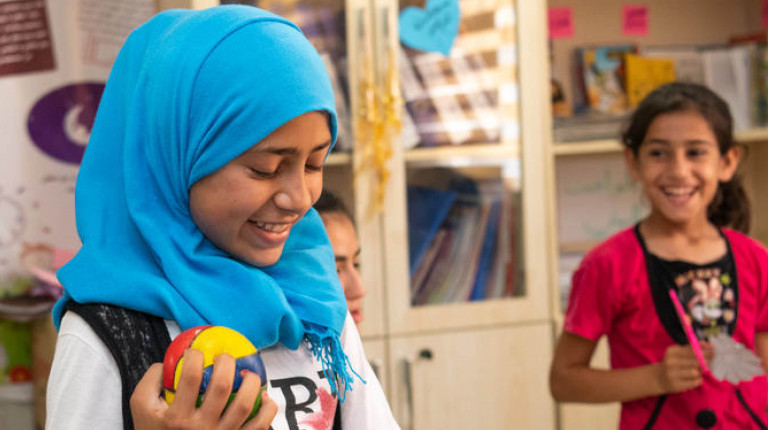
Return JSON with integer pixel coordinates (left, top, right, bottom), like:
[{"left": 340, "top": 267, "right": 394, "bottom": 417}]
[{"left": 377, "top": 0, "right": 547, "bottom": 332}]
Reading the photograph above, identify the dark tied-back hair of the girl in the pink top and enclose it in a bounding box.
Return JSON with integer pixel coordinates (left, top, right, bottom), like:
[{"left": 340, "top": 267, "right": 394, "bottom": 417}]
[{"left": 621, "top": 82, "right": 750, "bottom": 233}]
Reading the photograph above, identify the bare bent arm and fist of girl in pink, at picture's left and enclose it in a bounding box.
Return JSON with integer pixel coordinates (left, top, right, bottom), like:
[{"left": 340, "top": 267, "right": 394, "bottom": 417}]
[{"left": 550, "top": 331, "right": 711, "bottom": 403}]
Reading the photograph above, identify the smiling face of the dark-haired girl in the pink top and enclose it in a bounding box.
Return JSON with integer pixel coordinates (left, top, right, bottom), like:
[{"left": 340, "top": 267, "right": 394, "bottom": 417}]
[{"left": 625, "top": 111, "right": 739, "bottom": 228}]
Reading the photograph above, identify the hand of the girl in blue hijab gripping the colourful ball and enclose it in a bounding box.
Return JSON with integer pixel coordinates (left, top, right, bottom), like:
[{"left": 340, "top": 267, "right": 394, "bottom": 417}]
[{"left": 131, "top": 349, "right": 277, "bottom": 430}]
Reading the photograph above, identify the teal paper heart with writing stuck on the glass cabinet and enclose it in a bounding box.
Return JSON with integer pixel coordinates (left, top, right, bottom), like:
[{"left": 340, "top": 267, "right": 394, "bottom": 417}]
[{"left": 398, "top": 0, "right": 461, "bottom": 56}]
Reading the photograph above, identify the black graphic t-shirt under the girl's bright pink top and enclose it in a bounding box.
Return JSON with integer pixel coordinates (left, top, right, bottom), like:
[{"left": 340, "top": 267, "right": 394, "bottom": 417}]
[{"left": 635, "top": 227, "right": 738, "bottom": 344}]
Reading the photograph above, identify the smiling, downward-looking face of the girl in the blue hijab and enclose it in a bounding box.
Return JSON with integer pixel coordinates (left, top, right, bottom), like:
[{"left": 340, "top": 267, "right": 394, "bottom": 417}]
[{"left": 189, "top": 112, "right": 331, "bottom": 267}]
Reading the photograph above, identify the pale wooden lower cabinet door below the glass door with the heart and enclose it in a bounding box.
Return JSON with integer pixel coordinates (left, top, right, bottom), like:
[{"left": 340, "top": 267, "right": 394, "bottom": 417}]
[{"left": 390, "top": 323, "right": 555, "bottom": 429}]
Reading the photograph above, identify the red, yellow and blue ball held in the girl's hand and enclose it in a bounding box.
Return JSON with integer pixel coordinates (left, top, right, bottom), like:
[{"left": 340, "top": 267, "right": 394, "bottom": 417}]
[{"left": 163, "top": 325, "right": 267, "bottom": 419}]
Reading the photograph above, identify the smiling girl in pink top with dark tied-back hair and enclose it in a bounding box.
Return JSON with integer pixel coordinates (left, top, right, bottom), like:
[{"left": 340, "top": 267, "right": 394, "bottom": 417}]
[{"left": 550, "top": 83, "right": 768, "bottom": 430}]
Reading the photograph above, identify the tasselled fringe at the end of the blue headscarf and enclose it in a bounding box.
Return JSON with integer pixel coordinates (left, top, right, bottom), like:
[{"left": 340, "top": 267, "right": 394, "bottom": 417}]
[{"left": 304, "top": 323, "right": 367, "bottom": 402}]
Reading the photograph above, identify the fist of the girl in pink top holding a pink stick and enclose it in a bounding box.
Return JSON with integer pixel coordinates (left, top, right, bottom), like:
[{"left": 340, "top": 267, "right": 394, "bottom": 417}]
[{"left": 657, "top": 345, "right": 712, "bottom": 394}]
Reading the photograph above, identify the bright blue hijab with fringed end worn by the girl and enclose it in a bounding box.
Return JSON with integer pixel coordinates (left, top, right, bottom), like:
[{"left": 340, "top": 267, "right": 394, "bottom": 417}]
[{"left": 53, "top": 6, "right": 351, "bottom": 392}]
